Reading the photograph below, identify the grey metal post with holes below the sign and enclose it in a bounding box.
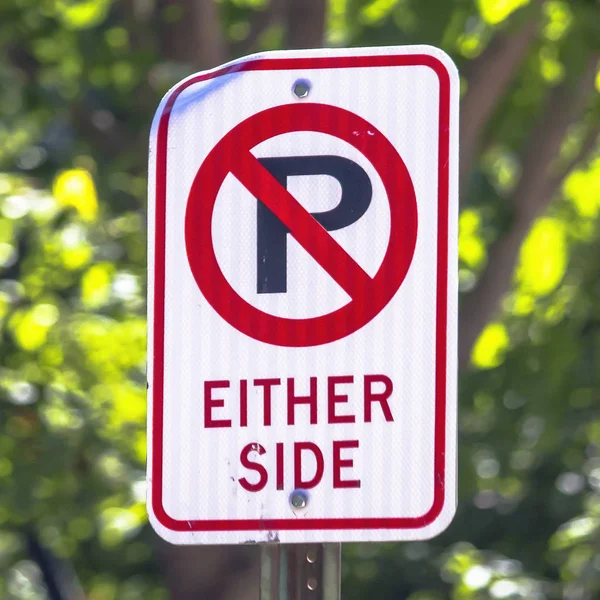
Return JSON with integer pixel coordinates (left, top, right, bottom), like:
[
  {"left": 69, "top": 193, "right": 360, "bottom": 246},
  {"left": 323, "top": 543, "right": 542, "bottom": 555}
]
[{"left": 260, "top": 544, "right": 342, "bottom": 600}]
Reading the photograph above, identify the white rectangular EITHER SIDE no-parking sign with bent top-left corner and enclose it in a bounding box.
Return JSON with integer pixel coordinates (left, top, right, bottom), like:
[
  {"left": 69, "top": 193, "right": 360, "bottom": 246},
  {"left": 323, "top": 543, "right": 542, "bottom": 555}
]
[{"left": 148, "top": 46, "right": 459, "bottom": 548}]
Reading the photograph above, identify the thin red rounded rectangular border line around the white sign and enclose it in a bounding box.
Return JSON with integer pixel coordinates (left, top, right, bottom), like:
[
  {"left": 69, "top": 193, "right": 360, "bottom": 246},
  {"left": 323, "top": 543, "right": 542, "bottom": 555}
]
[{"left": 151, "top": 54, "right": 450, "bottom": 532}]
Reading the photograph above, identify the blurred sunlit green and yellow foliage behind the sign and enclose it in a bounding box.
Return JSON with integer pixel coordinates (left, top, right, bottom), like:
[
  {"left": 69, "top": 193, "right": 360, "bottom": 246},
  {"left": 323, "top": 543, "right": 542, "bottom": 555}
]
[{"left": 0, "top": 0, "right": 600, "bottom": 600}]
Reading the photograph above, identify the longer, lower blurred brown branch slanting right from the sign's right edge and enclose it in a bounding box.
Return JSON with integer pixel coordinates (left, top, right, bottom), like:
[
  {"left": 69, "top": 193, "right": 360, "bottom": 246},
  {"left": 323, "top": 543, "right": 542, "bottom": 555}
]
[{"left": 459, "top": 55, "right": 599, "bottom": 368}]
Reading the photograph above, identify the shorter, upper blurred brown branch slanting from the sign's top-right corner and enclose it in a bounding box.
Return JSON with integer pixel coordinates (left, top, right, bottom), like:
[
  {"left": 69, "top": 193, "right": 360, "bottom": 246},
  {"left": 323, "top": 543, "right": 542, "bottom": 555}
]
[{"left": 459, "top": 10, "right": 540, "bottom": 187}]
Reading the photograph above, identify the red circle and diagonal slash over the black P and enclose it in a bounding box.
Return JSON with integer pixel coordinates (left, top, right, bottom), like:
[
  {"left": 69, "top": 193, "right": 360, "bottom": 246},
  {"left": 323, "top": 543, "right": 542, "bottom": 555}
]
[{"left": 185, "top": 103, "right": 417, "bottom": 347}]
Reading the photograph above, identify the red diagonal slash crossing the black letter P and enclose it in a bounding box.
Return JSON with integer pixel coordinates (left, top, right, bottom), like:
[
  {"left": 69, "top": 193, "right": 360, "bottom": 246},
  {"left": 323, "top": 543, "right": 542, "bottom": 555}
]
[{"left": 231, "top": 152, "right": 373, "bottom": 298}]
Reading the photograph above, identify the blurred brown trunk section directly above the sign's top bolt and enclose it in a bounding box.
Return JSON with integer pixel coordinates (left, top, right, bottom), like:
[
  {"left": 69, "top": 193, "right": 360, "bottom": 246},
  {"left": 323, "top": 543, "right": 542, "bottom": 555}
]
[{"left": 284, "top": 0, "right": 327, "bottom": 48}]
